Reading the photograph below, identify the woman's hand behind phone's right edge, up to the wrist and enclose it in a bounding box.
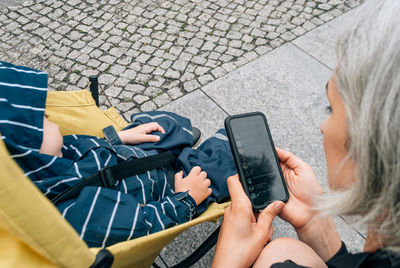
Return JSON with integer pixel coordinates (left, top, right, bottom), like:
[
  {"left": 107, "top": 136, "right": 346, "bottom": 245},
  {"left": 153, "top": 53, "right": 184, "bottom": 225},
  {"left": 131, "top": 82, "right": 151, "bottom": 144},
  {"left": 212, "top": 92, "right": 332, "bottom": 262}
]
[{"left": 276, "top": 148, "right": 322, "bottom": 230}]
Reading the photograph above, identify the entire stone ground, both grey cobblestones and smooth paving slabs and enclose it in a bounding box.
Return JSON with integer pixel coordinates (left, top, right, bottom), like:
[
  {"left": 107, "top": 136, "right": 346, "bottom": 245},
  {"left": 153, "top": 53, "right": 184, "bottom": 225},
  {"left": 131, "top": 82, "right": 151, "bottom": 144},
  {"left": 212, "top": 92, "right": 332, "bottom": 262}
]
[{"left": 0, "top": 0, "right": 365, "bottom": 267}]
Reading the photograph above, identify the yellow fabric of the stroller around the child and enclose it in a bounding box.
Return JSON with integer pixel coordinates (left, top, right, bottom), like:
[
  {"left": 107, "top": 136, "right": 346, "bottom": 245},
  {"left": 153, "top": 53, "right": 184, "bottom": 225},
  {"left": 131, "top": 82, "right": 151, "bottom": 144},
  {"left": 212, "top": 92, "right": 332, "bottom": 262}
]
[{"left": 0, "top": 90, "right": 227, "bottom": 267}]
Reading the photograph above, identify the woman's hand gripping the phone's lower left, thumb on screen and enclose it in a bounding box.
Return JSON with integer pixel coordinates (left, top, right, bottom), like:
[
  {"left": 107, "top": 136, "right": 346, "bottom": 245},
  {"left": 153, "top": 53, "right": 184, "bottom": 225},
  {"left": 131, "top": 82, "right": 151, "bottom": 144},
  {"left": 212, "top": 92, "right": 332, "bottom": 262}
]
[{"left": 212, "top": 175, "right": 284, "bottom": 268}]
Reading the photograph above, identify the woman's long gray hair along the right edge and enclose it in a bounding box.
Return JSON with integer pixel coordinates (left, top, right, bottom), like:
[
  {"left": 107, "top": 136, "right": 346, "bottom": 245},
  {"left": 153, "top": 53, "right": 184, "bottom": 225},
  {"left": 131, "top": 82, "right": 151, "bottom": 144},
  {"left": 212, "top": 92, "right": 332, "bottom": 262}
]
[{"left": 322, "top": 0, "right": 400, "bottom": 253}]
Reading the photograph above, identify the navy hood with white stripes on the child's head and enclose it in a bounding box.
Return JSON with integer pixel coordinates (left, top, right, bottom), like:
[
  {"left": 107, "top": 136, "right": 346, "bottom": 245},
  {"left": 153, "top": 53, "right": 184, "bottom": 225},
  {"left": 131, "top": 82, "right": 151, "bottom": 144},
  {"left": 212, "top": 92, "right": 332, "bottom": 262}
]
[{"left": 0, "top": 61, "right": 47, "bottom": 153}]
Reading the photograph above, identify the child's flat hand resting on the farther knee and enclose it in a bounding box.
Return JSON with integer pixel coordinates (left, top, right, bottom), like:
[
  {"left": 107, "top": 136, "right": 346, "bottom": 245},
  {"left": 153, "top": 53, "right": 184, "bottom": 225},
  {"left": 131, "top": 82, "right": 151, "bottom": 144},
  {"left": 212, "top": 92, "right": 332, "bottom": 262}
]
[{"left": 118, "top": 122, "right": 165, "bottom": 144}]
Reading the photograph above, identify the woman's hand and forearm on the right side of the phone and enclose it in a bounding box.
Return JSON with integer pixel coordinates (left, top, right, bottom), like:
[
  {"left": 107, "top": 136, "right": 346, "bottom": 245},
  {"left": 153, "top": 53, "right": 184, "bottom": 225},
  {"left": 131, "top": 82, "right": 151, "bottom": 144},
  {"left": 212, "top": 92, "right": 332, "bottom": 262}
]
[{"left": 277, "top": 148, "right": 341, "bottom": 261}]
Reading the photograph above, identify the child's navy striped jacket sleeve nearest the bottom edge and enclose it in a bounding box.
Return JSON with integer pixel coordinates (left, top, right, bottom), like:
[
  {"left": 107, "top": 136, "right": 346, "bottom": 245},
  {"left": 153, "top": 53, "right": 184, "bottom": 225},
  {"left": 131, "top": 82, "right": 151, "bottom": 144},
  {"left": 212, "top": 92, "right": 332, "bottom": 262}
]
[{"left": 59, "top": 186, "right": 208, "bottom": 247}]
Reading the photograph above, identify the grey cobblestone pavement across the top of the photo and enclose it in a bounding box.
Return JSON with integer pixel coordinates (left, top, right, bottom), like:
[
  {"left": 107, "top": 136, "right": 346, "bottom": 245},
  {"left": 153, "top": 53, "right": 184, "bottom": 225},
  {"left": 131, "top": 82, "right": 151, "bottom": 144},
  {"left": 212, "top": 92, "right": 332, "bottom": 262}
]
[{"left": 0, "top": 0, "right": 362, "bottom": 118}]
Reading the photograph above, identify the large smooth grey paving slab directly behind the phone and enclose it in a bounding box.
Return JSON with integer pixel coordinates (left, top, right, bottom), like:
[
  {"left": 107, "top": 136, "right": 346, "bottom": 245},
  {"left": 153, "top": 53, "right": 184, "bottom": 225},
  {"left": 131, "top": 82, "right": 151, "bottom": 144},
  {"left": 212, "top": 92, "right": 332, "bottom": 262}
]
[{"left": 203, "top": 41, "right": 364, "bottom": 251}]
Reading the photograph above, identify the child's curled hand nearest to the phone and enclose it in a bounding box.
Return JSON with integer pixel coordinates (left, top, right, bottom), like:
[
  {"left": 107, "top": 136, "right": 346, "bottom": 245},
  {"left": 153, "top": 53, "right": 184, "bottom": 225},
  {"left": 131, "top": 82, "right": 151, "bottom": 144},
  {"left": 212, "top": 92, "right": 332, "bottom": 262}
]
[{"left": 175, "top": 167, "right": 212, "bottom": 205}]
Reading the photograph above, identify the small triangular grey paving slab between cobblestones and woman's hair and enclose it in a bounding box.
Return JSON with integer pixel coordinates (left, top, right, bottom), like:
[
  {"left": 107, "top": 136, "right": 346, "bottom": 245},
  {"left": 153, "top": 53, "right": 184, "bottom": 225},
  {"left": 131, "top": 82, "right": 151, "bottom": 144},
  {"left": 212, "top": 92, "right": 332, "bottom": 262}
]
[{"left": 292, "top": 8, "right": 357, "bottom": 69}]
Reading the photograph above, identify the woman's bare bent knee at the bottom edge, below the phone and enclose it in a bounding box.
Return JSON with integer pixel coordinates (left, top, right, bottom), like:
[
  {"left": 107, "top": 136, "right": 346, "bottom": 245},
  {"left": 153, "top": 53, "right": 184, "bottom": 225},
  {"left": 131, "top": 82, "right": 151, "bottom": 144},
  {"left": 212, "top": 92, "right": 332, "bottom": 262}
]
[{"left": 254, "top": 237, "right": 326, "bottom": 268}]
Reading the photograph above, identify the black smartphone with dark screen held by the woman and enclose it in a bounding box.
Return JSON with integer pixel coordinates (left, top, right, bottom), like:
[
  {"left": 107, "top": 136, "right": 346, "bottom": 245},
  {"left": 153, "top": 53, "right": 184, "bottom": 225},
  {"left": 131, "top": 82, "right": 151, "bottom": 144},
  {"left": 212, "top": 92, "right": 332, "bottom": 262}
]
[{"left": 225, "top": 112, "right": 289, "bottom": 210}]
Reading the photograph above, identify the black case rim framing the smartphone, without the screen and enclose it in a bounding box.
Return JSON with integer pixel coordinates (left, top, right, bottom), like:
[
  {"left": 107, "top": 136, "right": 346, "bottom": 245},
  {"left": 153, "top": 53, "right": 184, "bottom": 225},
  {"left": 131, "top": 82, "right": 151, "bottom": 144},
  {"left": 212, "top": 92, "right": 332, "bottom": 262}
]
[{"left": 224, "top": 112, "right": 289, "bottom": 210}]
